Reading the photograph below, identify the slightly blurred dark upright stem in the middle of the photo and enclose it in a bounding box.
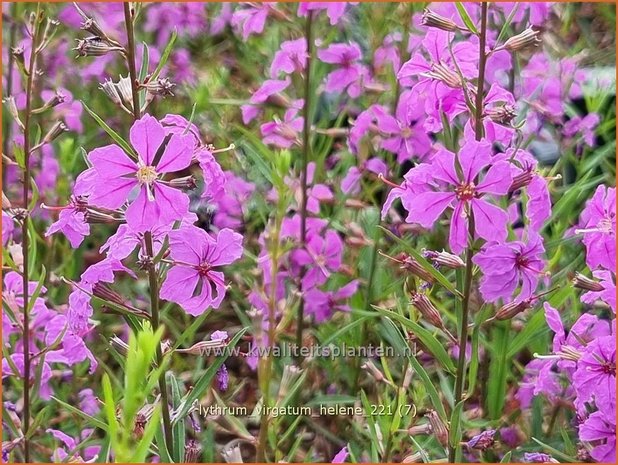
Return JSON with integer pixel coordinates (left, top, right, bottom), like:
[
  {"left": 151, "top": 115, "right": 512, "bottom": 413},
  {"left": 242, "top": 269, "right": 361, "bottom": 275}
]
[{"left": 296, "top": 11, "right": 314, "bottom": 358}]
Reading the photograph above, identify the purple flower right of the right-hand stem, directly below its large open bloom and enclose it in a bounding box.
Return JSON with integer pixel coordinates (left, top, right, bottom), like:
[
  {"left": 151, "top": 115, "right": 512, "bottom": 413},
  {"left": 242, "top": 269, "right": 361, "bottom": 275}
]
[{"left": 472, "top": 233, "right": 545, "bottom": 302}]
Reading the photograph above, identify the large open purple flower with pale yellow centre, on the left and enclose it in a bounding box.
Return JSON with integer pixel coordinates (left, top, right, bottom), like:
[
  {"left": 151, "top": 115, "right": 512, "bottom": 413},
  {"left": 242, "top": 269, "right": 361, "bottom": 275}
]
[{"left": 78, "top": 115, "right": 193, "bottom": 231}]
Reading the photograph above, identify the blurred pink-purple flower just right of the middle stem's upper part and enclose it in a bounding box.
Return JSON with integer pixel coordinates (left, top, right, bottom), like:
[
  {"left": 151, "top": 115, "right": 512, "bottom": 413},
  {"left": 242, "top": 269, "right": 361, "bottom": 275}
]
[{"left": 318, "top": 43, "right": 368, "bottom": 98}]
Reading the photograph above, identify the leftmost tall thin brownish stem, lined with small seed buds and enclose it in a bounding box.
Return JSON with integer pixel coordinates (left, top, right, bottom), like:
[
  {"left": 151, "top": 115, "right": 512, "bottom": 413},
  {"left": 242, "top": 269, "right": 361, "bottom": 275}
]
[{"left": 21, "top": 7, "right": 42, "bottom": 463}]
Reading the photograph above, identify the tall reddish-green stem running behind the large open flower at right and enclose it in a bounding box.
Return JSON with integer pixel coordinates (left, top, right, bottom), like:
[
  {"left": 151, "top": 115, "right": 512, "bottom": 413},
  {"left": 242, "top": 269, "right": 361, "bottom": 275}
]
[{"left": 448, "top": 2, "right": 487, "bottom": 463}]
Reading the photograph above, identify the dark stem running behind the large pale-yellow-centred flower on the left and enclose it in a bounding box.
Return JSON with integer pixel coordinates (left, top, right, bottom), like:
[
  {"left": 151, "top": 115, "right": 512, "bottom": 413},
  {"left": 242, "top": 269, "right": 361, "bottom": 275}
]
[{"left": 124, "top": 2, "right": 172, "bottom": 451}]
